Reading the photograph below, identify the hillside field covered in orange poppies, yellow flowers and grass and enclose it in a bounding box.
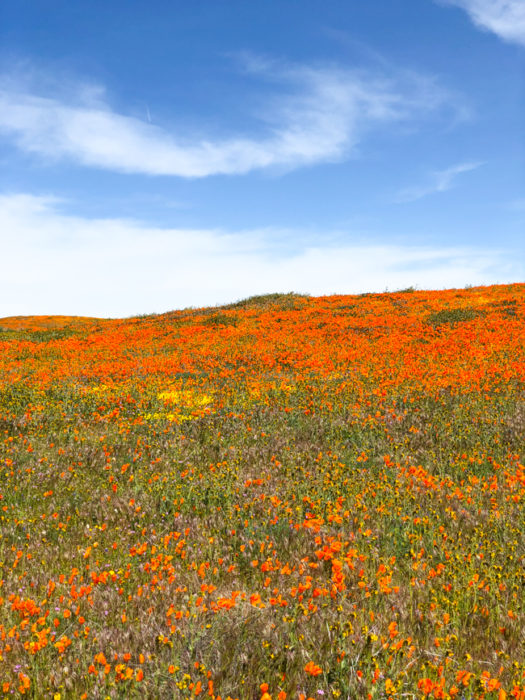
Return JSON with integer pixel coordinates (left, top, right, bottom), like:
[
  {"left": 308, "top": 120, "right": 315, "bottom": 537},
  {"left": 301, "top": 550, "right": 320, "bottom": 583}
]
[{"left": 0, "top": 284, "right": 525, "bottom": 700}]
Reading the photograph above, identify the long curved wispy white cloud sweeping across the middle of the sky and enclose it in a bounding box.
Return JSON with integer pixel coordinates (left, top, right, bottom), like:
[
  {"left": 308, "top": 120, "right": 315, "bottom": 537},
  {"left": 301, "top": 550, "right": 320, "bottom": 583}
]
[{"left": 0, "top": 62, "right": 461, "bottom": 178}]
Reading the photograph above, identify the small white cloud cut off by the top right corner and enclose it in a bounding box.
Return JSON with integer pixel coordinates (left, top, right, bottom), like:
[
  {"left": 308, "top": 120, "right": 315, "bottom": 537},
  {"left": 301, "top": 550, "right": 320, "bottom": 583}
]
[{"left": 438, "top": 0, "right": 525, "bottom": 46}]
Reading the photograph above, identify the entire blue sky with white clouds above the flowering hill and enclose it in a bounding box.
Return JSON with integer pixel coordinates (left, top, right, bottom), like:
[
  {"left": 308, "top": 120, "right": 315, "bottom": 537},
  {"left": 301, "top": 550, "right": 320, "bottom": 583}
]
[{"left": 0, "top": 0, "right": 525, "bottom": 316}]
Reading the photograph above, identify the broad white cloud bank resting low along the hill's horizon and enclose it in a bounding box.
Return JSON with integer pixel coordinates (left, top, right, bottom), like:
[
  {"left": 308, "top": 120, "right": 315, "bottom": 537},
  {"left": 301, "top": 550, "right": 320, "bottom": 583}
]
[{"left": 0, "top": 189, "right": 525, "bottom": 317}]
